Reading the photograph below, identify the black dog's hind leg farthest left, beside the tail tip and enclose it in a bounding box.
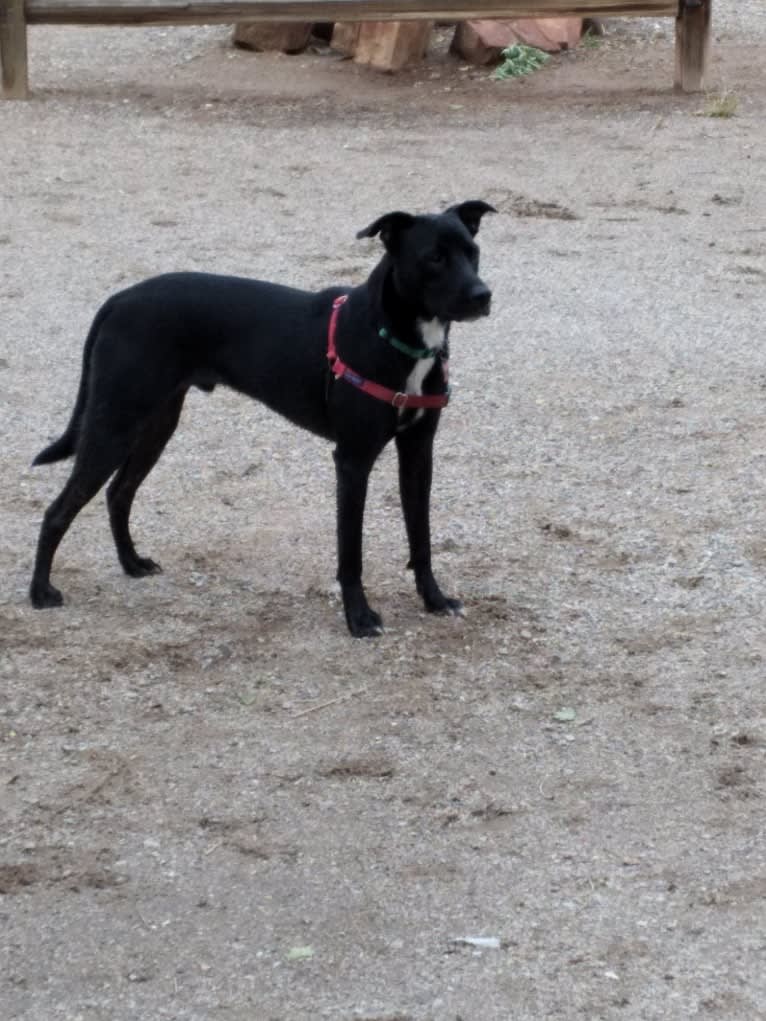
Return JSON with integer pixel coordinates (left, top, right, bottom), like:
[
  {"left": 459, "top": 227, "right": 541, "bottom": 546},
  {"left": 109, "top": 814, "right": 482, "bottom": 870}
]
[{"left": 30, "top": 431, "right": 140, "bottom": 610}]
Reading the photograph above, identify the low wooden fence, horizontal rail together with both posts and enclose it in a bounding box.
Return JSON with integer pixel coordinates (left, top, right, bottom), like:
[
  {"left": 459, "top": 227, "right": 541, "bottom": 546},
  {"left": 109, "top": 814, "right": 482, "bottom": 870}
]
[{"left": 0, "top": 0, "right": 712, "bottom": 99}]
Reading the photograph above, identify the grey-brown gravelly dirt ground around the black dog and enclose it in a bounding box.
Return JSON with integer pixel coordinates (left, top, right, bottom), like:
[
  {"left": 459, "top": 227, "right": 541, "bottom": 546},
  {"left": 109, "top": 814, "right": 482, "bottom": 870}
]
[{"left": 0, "top": 9, "right": 766, "bottom": 1021}]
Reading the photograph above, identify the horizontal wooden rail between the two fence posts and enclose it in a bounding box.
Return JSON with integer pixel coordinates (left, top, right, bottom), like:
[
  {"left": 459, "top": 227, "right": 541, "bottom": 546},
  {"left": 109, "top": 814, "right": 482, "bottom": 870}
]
[{"left": 26, "top": 0, "right": 678, "bottom": 25}]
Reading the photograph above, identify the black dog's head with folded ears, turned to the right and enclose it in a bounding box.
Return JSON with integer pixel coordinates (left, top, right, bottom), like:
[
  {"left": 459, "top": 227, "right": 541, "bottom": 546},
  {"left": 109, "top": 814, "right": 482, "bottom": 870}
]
[{"left": 356, "top": 200, "right": 496, "bottom": 323}]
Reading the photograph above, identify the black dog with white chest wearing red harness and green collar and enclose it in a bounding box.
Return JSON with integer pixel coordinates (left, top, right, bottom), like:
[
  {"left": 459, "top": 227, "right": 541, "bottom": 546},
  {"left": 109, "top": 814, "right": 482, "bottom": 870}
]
[{"left": 30, "top": 201, "right": 495, "bottom": 636}]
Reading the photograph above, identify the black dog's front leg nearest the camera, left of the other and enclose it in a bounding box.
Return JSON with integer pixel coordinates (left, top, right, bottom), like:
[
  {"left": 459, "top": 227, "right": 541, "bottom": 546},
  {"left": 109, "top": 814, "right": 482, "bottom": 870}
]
[{"left": 333, "top": 446, "right": 383, "bottom": 638}]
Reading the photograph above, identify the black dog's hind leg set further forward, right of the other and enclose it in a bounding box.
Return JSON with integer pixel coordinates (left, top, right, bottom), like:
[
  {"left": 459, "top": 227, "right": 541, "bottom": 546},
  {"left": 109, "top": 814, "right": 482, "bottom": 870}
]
[{"left": 106, "top": 390, "right": 186, "bottom": 578}]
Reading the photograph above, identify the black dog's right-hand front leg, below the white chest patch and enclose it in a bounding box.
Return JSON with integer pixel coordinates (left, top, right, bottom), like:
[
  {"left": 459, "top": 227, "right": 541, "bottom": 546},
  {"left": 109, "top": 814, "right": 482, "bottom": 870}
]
[{"left": 396, "top": 417, "right": 463, "bottom": 615}]
